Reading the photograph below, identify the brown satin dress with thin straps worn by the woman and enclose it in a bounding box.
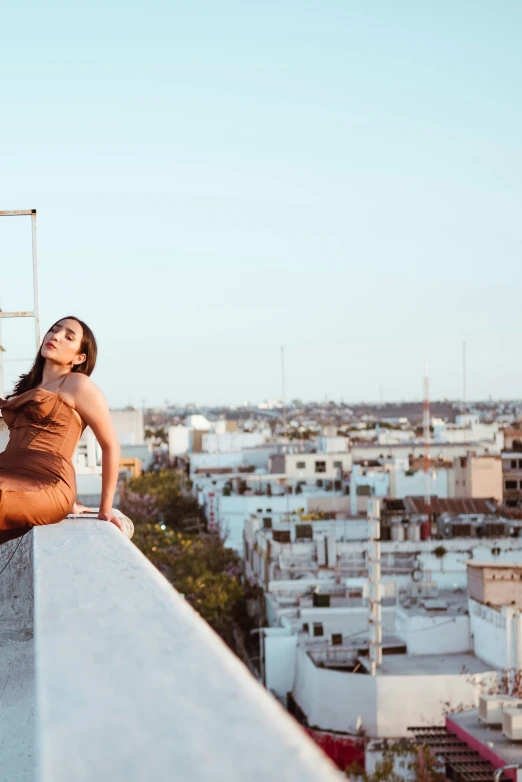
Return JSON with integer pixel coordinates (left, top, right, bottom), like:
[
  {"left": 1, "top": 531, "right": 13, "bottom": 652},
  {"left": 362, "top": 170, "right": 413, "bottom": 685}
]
[{"left": 0, "top": 388, "right": 85, "bottom": 542}]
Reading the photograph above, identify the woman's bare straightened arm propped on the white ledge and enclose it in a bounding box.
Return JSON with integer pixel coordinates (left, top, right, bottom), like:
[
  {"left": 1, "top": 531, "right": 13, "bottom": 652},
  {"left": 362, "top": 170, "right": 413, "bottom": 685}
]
[{"left": 67, "top": 373, "right": 120, "bottom": 526}]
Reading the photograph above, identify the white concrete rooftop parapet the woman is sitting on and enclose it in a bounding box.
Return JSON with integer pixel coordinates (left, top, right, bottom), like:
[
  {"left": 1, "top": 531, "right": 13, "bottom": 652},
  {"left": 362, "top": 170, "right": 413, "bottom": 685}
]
[{"left": 0, "top": 520, "right": 340, "bottom": 782}]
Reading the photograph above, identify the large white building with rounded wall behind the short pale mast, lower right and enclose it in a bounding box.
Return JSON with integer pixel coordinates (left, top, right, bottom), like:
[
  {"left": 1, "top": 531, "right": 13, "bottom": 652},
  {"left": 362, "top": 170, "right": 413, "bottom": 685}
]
[{"left": 261, "top": 588, "right": 495, "bottom": 738}]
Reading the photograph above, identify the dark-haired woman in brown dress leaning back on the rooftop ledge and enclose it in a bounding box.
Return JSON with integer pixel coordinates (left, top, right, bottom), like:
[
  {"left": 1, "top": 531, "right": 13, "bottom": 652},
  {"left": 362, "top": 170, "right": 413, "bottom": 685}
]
[{"left": 0, "top": 316, "right": 128, "bottom": 542}]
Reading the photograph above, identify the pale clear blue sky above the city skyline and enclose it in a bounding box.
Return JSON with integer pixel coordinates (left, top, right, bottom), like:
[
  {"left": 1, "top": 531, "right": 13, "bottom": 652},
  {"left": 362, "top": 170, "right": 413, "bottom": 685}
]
[{"left": 0, "top": 0, "right": 522, "bottom": 405}]
